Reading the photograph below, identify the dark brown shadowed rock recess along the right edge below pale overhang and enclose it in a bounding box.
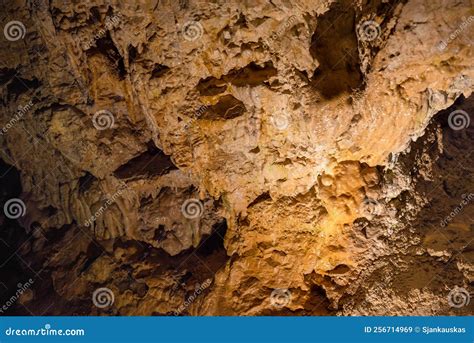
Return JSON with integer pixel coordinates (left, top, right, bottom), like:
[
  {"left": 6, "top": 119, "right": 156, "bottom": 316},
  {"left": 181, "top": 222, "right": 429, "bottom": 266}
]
[{"left": 372, "top": 96, "right": 474, "bottom": 314}]
